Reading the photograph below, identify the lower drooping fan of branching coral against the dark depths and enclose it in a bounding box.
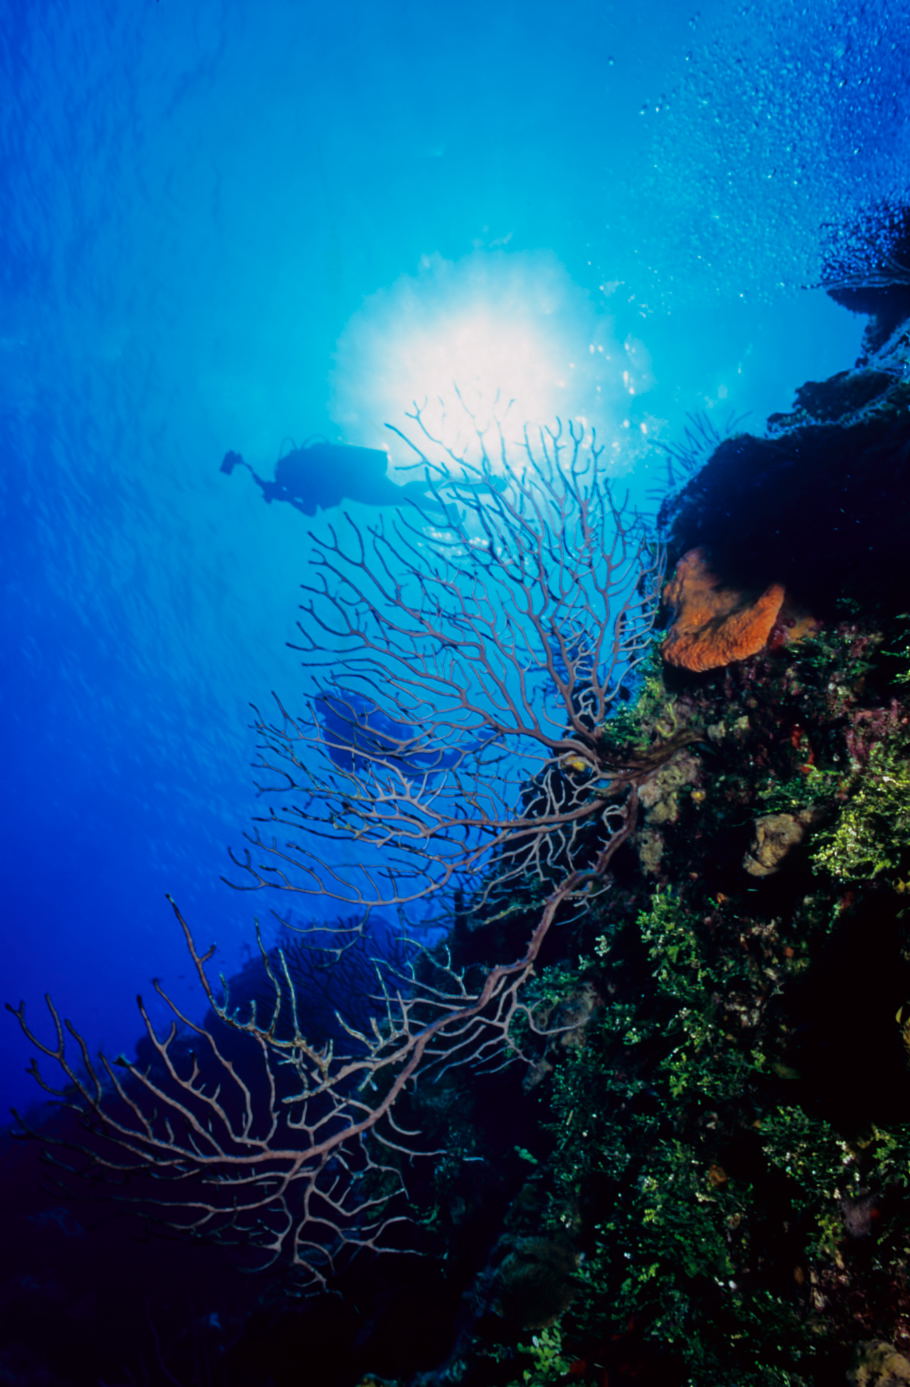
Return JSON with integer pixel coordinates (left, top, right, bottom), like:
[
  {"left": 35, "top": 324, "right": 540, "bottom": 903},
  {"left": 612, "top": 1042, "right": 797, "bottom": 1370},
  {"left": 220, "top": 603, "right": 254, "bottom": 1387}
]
[{"left": 8, "top": 837, "right": 633, "bottom": 1286}]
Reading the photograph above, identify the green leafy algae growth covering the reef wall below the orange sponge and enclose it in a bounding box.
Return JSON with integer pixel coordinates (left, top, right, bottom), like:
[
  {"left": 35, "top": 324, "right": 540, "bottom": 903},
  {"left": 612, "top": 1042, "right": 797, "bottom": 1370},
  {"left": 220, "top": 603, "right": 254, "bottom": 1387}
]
[{"left": 482, "top": 588, "right": 910, "bottom": 1387}]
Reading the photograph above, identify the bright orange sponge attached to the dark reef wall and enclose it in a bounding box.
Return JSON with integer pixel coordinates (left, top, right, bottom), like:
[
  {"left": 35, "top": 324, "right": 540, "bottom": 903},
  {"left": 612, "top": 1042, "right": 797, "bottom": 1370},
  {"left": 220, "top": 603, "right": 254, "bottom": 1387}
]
[{"left": 662, "top": 549, "right": 785, "bottom": 673}]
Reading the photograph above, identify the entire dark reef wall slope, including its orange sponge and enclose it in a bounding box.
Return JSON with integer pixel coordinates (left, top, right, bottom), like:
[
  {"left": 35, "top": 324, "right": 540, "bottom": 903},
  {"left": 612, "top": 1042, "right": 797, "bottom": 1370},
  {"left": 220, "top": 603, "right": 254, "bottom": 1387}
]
[{"left": 377, "top": 216, "right": 910, "bottom": 1387}]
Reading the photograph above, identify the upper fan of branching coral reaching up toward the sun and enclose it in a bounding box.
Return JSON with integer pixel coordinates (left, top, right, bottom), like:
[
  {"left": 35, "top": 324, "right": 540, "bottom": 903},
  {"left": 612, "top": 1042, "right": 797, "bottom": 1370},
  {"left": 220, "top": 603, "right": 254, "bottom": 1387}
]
[{"left": 233, "top": 409, "right": 662, "bottom": 908}]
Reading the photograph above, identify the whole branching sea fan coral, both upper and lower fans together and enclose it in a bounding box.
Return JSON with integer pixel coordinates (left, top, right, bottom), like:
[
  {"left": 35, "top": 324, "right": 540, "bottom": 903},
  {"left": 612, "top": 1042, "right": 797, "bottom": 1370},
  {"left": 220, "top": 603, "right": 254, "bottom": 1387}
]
[{"left": 11, "top": 409, "right": 665, "bottom": 1284}]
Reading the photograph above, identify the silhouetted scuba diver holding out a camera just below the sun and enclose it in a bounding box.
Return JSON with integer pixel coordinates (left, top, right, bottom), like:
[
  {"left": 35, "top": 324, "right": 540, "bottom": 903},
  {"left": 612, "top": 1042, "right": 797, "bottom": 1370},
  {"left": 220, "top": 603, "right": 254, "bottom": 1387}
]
[{"left": 221, "top": 440, "right": 444, "bottom": 516}]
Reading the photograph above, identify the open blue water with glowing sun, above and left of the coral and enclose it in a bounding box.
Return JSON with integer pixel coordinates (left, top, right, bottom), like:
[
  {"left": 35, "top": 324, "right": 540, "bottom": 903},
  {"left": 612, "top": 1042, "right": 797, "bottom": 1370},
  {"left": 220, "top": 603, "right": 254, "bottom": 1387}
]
[{"left": 0, "top": 0, "right": 910, "bottom": 1126}]
